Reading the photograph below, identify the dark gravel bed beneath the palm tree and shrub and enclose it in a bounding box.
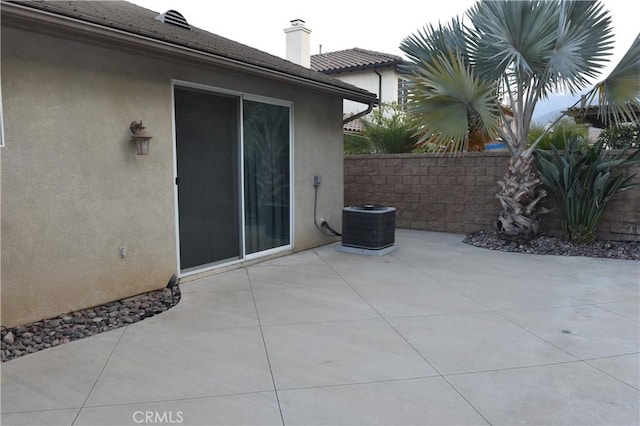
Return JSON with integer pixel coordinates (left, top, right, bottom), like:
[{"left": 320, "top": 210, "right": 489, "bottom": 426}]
[{"left": 463, "top": 231, "right": 640, "bottom": 260}]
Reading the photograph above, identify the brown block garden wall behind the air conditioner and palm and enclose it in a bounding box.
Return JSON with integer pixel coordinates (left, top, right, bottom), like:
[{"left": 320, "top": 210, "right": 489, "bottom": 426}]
[{"left": 344, "top": 152, "right": 640, "bottom": 241}]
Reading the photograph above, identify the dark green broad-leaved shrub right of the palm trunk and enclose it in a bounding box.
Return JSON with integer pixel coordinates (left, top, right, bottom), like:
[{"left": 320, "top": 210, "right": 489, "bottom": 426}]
[{"left": 536, "top": 138, "right": 640, "bottom": 244}]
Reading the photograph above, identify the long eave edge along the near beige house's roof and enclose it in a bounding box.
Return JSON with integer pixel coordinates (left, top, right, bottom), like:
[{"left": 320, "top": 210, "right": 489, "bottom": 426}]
[{"left": 0, "top": 1, "right": 379, "bottom": 104}]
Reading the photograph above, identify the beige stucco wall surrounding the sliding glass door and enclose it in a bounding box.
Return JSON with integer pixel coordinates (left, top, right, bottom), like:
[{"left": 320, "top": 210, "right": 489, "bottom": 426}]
[{"left": 1, "top": 26, "right": 343, "bottom": 326}]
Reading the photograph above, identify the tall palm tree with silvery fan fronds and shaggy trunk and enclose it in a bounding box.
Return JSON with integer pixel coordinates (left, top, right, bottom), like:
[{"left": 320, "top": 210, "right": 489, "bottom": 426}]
[{"left": 400, "top": 0, "right": 640, "bottom": 238}]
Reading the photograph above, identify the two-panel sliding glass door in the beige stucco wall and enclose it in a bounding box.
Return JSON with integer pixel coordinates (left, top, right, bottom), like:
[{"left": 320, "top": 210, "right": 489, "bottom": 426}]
[{"left": 174, "top": 86, "right": 292, "bottom": 273}]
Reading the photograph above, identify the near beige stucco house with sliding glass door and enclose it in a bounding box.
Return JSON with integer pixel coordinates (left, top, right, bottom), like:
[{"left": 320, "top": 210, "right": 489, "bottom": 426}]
[{"left": 0, "top": 1, "right": 376, "bottom": 327}]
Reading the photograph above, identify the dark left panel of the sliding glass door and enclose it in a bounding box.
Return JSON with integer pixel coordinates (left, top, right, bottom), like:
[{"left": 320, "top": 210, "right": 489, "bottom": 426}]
[{"left": 175, "top": 87, "right": 241, "bottom": 270}]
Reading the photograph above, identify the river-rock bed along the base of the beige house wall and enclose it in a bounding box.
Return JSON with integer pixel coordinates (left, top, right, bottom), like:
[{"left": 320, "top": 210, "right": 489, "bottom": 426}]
[{"left": 0, "top": 286, "right": 180, "bottom": 362}]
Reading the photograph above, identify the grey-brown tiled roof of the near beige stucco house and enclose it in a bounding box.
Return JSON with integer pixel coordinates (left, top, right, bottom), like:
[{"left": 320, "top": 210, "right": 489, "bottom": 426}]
[{"left": 2, "top": 0, "right": 376, "bottom": 100}]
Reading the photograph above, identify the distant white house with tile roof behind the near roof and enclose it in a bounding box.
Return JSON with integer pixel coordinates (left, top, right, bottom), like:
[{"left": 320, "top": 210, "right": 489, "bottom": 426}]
[{"left": 311, "top": 48, "right": 407, "bottom": 115}]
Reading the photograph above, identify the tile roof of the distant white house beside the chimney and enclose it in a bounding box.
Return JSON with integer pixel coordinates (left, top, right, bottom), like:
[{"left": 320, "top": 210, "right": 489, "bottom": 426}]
[{"left": 311, "top": 47, "right": 403, "bottom": 74}]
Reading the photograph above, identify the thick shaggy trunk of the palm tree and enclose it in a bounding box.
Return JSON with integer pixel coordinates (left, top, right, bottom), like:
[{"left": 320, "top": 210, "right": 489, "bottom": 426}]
[{"left": 496, "top": 150, "right": 548, "bottom": 240}]
